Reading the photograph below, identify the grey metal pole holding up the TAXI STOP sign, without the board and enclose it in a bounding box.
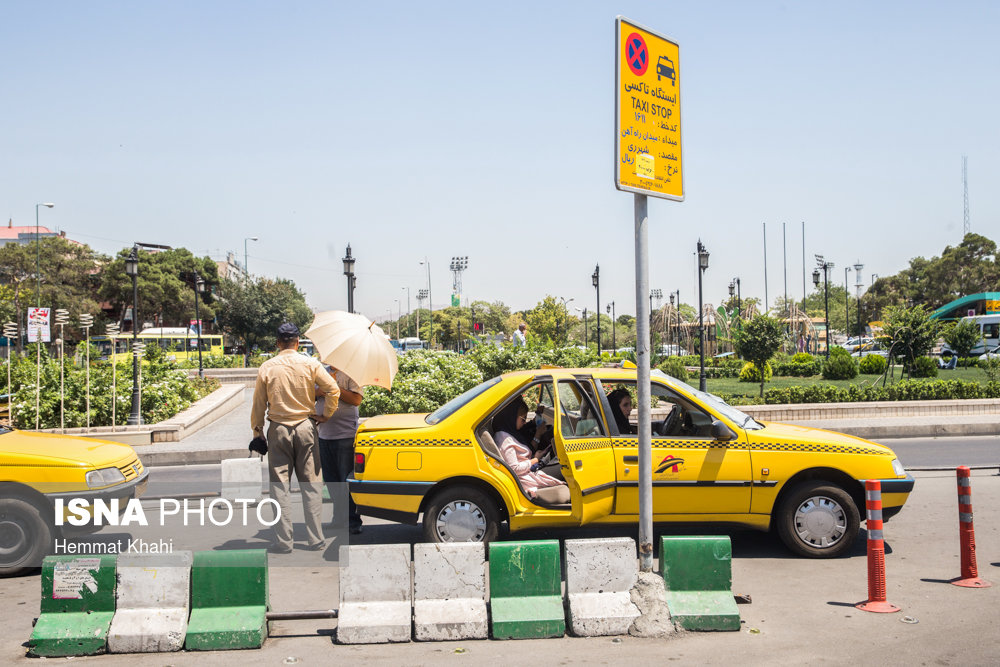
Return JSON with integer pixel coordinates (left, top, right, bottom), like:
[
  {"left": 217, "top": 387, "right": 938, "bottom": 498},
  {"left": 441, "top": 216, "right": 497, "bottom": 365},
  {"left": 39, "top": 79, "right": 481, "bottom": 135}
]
[{"left": 634, "top": 194, "right": 653, "bottom": 572}]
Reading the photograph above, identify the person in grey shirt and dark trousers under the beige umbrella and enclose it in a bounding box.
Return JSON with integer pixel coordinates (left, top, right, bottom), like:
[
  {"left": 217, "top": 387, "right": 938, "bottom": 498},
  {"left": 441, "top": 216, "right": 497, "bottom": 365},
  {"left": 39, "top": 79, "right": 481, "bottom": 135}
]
[{"left": 316, "top": 366, "right": 365, "bottom": 535}]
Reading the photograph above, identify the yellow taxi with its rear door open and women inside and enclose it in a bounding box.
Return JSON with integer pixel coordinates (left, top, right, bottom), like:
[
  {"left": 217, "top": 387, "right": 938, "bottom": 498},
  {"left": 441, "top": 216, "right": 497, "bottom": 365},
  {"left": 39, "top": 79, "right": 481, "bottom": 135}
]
[{"left": 349, "top": 368, "right": 913, "bottom": 558}]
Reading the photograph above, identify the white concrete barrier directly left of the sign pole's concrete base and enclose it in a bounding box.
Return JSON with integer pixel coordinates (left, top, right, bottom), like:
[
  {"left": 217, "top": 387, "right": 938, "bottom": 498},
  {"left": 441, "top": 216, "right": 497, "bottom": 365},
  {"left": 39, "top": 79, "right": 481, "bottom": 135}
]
[{"left": 563, "top": 537, "right": 639, "bottom": 637}]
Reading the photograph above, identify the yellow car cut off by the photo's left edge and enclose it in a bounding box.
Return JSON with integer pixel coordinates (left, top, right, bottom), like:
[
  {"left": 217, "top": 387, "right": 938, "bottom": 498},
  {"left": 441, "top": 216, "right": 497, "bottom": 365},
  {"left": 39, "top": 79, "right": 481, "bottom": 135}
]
[{"left": 0, "top": 426, "right": 149, "bottom": 576}]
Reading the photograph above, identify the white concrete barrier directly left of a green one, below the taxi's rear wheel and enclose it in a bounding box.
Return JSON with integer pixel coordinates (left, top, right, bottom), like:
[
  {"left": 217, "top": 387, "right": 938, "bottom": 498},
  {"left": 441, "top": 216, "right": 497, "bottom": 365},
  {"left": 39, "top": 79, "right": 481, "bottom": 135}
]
[{"left": 413, "top": 542, "right": 489, "bottom": 641}]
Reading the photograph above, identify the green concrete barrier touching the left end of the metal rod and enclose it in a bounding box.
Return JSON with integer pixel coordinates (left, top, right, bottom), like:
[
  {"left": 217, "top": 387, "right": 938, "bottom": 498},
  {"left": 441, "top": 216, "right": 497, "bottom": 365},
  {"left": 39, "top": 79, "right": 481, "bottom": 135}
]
[{"left": 184, "top": 549, "right": 268, "bottom": 651}]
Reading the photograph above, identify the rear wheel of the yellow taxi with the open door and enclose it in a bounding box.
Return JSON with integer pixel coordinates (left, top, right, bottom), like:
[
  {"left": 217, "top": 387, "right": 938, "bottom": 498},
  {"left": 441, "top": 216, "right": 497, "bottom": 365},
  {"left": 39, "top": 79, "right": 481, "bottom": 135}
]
[{"left": 424, "top": 486, "right": 500, "bottom": 542}]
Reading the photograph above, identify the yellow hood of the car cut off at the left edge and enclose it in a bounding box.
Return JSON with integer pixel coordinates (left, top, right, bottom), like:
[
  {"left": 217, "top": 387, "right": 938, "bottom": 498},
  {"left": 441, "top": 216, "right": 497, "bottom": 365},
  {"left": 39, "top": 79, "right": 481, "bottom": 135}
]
[{"left": 0, "top": 431, "right": 136, "bottom": 468}]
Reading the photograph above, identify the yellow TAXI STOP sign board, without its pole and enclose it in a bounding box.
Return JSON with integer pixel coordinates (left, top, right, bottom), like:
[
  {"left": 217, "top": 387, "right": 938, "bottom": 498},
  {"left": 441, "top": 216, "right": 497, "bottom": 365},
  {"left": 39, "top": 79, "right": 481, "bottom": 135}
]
[{"left": 615, "top": 16, "right": 684, "bottom": 201}]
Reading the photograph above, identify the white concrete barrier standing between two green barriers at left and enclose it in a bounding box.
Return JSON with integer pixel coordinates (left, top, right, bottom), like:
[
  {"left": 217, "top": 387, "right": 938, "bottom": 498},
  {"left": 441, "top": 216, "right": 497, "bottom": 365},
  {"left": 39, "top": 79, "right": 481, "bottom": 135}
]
[{"left": 108, "top": 551, "right": 192, "bottom": 653}]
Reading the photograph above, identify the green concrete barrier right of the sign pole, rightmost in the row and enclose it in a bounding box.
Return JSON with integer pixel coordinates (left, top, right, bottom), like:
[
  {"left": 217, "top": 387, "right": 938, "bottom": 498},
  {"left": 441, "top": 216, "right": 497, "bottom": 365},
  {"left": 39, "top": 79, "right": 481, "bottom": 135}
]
[{"left": 660, "top": 536, "right": 740, "bottom": 630}]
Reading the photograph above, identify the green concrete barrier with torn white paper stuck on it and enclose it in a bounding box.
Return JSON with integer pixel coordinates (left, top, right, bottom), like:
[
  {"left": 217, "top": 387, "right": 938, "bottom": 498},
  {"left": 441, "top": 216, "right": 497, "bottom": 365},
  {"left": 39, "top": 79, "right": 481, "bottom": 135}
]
[{"left": 28, "top": 555, "right": 117, "bottom": 657}]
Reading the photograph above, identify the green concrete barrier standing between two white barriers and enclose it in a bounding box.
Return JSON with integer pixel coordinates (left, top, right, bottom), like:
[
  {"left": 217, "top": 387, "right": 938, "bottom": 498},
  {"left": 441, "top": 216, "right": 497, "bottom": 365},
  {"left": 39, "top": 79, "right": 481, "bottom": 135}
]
[{"left": 490, "top": 540, "right": 566, "bottom": 639}]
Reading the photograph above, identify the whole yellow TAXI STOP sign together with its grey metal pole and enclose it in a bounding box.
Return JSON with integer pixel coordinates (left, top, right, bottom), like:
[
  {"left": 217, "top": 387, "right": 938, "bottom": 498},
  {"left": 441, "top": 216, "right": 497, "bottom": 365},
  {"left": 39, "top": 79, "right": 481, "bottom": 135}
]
[{"left": 614, "top": 16, "right": 684, "bottom": 572}]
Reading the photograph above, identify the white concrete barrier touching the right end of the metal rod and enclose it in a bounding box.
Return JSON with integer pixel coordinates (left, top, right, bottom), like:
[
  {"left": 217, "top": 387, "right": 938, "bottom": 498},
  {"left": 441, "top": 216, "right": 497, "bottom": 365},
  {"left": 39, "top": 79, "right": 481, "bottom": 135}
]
[{"left": 337, "top": 544, "right": 413, "bottom": 644}]
